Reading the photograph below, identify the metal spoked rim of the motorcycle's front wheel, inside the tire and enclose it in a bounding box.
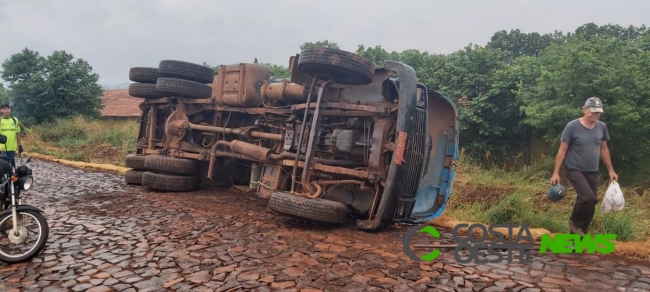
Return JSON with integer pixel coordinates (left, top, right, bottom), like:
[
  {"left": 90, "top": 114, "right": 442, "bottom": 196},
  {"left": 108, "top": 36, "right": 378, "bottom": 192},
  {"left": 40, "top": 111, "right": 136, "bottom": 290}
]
[{"left": 0, "top": 213, "right": 43, "bottom": 258}]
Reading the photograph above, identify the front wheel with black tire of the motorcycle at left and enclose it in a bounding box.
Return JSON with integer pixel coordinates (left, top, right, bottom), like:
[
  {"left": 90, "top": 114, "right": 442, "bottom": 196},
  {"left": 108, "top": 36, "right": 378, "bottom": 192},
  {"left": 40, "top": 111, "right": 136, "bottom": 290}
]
[{"left": 0, "top": 210, "right": 49, "bottom": 263}]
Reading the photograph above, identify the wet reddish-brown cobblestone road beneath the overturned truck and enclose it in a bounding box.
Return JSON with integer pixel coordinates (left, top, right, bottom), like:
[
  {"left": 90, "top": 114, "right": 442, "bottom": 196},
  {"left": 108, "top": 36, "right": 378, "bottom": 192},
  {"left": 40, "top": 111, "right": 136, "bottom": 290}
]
[{"left": 0, "top": 161, "right": 650, "bottom": 292}]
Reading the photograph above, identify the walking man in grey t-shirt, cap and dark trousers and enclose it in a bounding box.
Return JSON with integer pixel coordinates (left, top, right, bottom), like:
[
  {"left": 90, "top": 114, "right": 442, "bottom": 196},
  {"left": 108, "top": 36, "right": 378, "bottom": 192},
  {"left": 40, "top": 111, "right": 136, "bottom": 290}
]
[{"left": 551, "top": 97, "right": 618, "bottom": 236}]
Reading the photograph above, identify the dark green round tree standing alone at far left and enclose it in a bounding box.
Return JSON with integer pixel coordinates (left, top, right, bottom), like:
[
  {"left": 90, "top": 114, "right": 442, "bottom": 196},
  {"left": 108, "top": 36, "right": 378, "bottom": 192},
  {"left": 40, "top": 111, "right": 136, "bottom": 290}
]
[{"left": 2, "top": 48, "right": 103, "bottom": 123}]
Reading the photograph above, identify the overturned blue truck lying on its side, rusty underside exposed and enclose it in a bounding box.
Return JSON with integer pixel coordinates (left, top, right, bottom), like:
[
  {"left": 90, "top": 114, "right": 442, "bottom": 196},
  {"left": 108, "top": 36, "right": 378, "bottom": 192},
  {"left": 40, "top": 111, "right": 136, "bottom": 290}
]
[{"left": 125, "top": 47, "right": 459, "bottom": 231}]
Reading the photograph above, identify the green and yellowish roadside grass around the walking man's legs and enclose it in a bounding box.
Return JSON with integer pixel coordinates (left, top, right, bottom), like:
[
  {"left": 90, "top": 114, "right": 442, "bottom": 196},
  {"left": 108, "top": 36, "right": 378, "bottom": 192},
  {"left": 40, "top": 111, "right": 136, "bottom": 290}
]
[{"left": 446, "top": 148, "right": 650, "bottom": 241}]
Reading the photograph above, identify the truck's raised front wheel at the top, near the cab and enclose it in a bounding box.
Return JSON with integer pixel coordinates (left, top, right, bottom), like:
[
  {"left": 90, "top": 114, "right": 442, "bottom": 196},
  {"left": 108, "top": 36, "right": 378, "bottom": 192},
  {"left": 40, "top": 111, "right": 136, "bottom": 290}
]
[{"left": 298, "top": 47, "right": 375, "bottom": 85}]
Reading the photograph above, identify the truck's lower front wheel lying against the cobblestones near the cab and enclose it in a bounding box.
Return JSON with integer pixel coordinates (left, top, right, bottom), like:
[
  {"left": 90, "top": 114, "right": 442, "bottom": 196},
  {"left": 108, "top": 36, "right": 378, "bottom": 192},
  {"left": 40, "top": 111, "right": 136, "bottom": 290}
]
[{"left": 268, "top": 192, "right": 348, "bottom": 224}]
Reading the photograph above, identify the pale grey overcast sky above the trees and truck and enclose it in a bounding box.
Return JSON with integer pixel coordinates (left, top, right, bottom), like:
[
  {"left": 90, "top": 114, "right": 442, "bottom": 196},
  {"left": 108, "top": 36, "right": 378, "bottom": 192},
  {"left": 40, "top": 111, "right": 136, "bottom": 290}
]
[{"left": 0, "top": 0, "right": 650, "bottom": 86}]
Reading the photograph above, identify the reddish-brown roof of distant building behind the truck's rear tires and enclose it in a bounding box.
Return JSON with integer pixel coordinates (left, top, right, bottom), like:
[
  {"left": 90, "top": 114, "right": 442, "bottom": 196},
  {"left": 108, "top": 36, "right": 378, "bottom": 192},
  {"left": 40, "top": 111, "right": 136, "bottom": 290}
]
[{"left": 100, "top": 89, "right": 144, "bottom": 119}]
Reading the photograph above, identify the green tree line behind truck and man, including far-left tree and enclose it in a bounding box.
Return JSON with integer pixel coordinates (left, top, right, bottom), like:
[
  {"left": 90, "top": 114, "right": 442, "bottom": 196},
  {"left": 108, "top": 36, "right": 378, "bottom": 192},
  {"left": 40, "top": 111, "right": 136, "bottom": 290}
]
[{"left": 0, "top": 23, "right": 650, "bottom": 185}]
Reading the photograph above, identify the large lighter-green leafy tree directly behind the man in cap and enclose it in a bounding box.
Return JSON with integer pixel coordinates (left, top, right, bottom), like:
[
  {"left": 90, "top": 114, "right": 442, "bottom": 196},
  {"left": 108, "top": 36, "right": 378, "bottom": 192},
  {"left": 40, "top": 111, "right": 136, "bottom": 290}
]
[{"left": 517, "top": 34, "right": 650, "bottom": 178}]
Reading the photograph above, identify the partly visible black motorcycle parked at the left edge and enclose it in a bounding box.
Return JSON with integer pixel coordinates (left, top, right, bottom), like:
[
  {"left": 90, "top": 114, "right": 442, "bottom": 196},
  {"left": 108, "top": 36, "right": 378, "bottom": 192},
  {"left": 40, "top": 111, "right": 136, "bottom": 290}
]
[{"left": 0, "top": 134, "right": 49, "bottom": 263}]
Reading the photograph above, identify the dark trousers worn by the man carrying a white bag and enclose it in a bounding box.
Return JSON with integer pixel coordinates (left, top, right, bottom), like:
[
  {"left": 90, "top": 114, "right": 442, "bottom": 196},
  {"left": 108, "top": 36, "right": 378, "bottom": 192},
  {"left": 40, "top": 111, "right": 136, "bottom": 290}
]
[{"left": 566, "top": 169, "right": 598, "bottom": 234}]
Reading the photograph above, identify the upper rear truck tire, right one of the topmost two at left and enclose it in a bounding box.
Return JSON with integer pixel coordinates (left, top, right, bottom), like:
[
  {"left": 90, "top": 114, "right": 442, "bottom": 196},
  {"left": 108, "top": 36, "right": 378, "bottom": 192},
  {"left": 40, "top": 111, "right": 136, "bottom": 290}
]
[{"left": 158, "top": 60, "right": 214, "bottom": 84}]
